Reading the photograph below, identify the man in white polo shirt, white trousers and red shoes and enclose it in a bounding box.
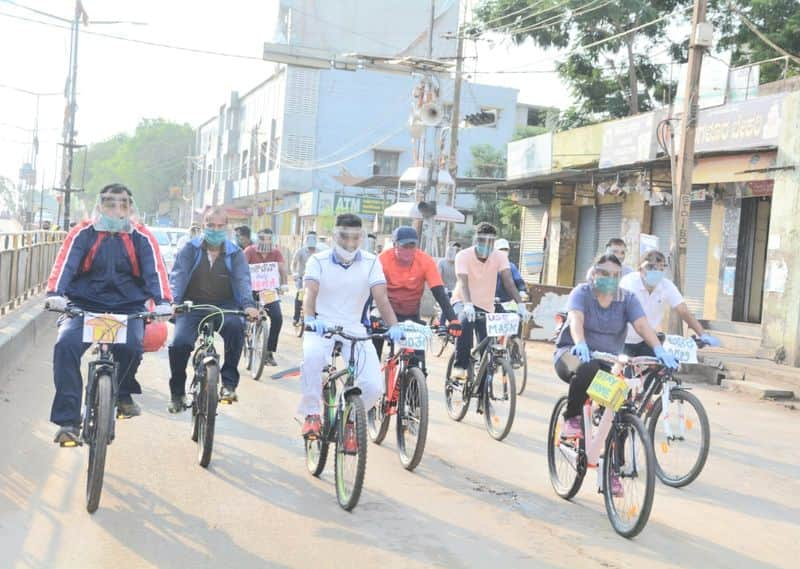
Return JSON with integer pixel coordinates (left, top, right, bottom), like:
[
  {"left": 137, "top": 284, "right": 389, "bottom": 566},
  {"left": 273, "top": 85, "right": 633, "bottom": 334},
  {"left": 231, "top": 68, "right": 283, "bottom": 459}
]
[{"left": 298, "top": 213, "right": 403, "bottom": 444}]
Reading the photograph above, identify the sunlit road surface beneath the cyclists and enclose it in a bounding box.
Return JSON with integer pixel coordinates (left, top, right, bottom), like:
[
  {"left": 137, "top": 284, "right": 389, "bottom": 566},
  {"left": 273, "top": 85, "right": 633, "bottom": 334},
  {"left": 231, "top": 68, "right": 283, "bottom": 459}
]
[{"left": 0, "top": 310, "right": 800, "bottom": 568}]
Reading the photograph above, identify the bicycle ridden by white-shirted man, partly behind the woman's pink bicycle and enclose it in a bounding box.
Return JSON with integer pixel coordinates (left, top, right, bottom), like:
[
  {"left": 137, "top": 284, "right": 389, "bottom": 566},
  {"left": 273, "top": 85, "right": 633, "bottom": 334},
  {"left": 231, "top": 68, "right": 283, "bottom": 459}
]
[{"left": 632, "top": 334, "right": 711, "bottom": 488}]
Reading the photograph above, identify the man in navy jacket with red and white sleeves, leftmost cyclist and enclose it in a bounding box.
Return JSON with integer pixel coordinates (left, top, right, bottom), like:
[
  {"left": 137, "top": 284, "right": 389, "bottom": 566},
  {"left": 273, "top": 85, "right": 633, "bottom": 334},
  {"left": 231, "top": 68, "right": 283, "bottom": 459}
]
[{"left": 47, "top": 184, "right": 172, "bottom": 444}]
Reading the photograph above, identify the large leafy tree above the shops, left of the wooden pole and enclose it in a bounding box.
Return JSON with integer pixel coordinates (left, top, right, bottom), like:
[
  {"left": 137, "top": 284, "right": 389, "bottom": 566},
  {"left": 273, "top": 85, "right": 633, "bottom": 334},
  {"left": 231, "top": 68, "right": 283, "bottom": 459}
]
[{"left": 475, "top": 0, "right": 690, "bottom": 128}]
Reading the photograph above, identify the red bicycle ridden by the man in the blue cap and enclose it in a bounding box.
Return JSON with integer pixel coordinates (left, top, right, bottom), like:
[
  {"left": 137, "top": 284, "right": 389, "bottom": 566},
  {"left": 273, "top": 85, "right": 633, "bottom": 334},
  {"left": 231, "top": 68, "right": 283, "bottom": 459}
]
[{"left": 367, "top": 322, "right": 434, "bottom": 471}]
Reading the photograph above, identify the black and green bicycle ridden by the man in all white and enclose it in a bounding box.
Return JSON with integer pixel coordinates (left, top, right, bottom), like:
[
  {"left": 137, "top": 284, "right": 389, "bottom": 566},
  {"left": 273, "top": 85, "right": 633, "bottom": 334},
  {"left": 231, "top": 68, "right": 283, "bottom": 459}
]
[{"left": 305, "top": 326, "right": 378, "bottom": 511}]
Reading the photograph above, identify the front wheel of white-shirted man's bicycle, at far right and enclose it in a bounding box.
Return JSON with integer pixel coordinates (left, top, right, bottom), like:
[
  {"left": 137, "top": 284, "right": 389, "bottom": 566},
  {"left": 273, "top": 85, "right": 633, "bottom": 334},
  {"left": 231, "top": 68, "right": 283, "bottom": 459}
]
[{"left": 647, "top": 389, "right": 711, "bottom": 488}]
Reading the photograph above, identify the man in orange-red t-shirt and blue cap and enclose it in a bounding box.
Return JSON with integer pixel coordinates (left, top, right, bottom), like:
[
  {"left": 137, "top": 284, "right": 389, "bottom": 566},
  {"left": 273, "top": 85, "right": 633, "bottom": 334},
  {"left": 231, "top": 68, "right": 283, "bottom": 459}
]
[{"left": 373, "top": 225, "right": 461, "bottom": 368}]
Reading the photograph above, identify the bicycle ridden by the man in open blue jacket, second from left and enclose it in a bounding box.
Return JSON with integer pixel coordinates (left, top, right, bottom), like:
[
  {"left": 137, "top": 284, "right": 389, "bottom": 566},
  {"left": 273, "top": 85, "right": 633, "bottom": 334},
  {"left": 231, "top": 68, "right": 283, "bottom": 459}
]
[{"left": 175, "top": 300, "right": 245, "bottom": 468}]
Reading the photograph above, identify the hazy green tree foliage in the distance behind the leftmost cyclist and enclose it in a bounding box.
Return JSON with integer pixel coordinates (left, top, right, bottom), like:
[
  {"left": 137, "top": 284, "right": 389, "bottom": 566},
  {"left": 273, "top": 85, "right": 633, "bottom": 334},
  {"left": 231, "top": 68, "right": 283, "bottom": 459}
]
[{"left": 74, "top": 119, "right": 194, "bottom": 214}]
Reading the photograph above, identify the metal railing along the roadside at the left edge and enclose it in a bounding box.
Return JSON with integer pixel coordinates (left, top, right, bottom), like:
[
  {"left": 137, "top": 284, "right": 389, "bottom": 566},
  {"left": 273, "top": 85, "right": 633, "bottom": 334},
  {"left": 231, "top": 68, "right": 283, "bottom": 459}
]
[{"left": 0, "top": 231, "right": 66, "bottom": 314}]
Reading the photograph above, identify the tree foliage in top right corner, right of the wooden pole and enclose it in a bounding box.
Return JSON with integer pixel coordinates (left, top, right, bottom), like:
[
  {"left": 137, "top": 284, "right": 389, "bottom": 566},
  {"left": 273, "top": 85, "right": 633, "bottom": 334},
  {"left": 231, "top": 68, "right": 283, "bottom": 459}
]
[{"left": 709, "top": 0, "right": 800, "bottom": 83}]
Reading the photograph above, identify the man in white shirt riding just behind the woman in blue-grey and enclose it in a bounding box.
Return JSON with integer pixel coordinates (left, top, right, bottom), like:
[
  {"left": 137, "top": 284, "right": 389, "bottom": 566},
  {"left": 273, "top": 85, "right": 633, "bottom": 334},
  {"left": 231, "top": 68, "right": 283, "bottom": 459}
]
[{"left": 619, "top": 250, "right": 720, "bottom": 356}]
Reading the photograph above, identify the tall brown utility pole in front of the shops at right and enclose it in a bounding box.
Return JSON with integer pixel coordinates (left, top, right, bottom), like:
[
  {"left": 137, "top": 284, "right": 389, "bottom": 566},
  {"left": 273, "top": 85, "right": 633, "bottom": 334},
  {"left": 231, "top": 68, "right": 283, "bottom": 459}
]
[{"left": 670, "top": 0, "right": 707, "bottom": 333}]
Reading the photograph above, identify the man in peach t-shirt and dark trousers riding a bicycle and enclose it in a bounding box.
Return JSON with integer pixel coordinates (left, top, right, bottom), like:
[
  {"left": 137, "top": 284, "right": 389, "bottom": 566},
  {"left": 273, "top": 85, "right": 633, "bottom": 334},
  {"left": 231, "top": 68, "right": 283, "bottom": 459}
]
[{"left": 451, "top": 223, "right": 528, "bottom": 379}]
